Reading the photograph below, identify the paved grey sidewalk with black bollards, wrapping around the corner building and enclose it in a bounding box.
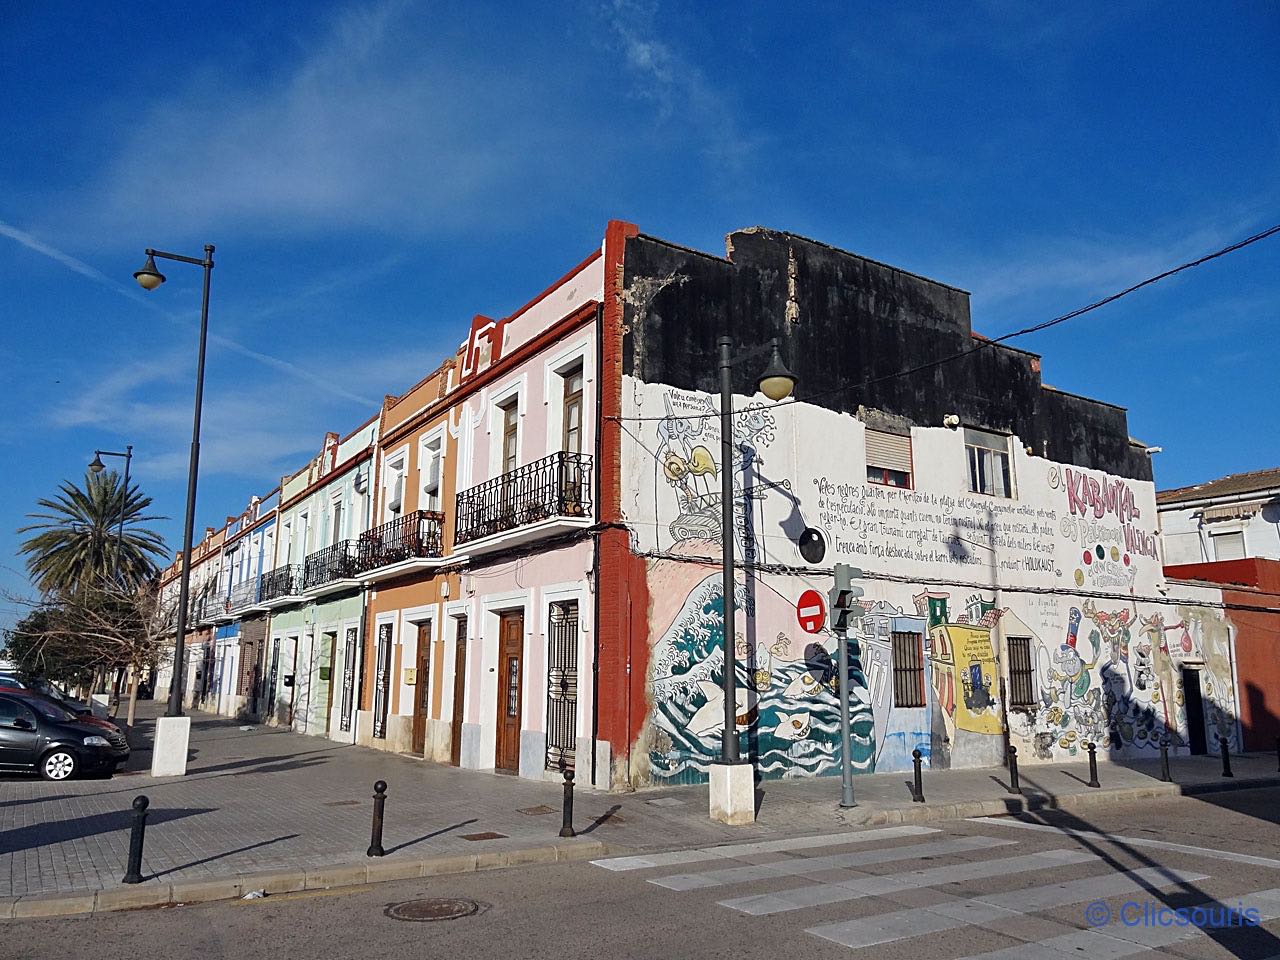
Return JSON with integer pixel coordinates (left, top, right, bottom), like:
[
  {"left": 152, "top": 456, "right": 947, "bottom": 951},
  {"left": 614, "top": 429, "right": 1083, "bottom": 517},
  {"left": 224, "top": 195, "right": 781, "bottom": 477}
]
[{"left": 0, "top": 704, "right": 1280, "bottom": 918}]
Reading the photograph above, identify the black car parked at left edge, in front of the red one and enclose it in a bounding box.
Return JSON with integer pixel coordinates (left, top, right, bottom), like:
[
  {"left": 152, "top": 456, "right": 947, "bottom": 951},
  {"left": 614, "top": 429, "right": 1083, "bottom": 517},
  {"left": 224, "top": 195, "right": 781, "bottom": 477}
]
[{"left": 0, "top": 694, "right": 129, "bottom": 781}]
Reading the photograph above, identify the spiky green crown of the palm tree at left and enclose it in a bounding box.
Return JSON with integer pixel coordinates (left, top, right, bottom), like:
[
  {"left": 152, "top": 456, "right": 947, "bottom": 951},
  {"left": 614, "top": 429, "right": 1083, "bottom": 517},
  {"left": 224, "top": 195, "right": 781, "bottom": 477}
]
[{"left": 18, "top": 470, "right": 166, "bottom": 595}]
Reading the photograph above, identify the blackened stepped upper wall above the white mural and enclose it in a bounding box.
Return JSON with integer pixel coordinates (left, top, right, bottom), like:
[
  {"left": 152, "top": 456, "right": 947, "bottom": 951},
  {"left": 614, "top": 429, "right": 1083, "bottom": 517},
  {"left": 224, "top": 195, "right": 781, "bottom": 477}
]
[{"left": 623, "top": 228, "right": 1151, "bottom": 480}]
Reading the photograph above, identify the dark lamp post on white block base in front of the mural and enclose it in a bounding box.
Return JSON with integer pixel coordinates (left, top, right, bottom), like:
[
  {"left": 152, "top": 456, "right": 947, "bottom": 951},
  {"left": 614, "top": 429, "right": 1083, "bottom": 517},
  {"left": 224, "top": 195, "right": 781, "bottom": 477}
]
[{"left": 710, "top": 337, "right": 796, "bottom": 824}]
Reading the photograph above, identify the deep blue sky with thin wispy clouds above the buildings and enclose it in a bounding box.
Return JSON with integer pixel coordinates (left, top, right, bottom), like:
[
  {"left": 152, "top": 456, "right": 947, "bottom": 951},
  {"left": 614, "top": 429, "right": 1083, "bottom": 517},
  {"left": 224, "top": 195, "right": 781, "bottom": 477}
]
[{"left": 0, "top": 0, "right": 1280, "bottom": 622}]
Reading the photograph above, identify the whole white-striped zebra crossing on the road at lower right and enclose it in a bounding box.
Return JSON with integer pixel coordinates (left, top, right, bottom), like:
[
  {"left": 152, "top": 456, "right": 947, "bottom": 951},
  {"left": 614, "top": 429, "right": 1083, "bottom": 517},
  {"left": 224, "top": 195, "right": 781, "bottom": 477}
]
[{"left": 593, "top": 820, "right": 1280, "bottom": 960}]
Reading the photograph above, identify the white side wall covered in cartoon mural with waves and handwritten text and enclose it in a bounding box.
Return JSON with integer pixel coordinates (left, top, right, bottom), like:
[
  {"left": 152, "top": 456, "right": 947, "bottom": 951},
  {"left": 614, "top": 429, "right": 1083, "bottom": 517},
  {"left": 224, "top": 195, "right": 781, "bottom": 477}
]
[{"left": 623, "top": 371, "right": 1235, "bottom": 782}]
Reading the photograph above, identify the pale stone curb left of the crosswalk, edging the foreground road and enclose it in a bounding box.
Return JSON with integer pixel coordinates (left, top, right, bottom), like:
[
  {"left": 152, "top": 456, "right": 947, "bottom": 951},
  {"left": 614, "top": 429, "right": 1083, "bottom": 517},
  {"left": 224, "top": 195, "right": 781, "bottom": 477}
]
[{"left": 0, "top": 840, "right": 613, "bottom": 920}]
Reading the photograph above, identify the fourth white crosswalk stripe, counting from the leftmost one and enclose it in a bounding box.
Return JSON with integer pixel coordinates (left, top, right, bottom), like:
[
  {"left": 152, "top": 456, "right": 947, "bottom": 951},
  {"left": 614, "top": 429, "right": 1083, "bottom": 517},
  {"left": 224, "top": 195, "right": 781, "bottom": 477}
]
[{"left": 805, "top": 867, "right": 1208, "bottom": 948}]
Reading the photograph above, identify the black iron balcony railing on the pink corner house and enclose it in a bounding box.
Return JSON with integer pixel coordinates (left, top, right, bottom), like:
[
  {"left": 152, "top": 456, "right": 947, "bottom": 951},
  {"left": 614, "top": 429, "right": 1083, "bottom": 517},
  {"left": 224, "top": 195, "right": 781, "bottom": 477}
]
[{"left": 454, "top": 452, "right": 591, "bottom": 544}]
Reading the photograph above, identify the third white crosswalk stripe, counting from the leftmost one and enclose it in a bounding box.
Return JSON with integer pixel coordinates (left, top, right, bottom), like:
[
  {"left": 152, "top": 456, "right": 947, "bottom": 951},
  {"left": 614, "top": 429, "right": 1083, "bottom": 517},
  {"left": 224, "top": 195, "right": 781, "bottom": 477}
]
[{"left": 719, "top": 850, "right": 1102, "bottom": 916}]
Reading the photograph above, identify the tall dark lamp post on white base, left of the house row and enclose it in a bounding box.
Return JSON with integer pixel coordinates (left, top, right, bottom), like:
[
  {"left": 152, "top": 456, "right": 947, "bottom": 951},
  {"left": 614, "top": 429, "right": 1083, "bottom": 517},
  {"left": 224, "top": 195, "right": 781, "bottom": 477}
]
[{"left": 133, "top": 243, "right": 214, "bottom": 777}]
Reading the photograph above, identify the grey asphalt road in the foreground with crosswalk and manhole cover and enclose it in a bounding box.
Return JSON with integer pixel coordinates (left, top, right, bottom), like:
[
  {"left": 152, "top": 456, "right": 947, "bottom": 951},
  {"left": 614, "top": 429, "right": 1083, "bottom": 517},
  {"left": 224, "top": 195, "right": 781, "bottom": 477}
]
[{"left": 10, "top": 790, "right": 1280, "bottom": 960}]
